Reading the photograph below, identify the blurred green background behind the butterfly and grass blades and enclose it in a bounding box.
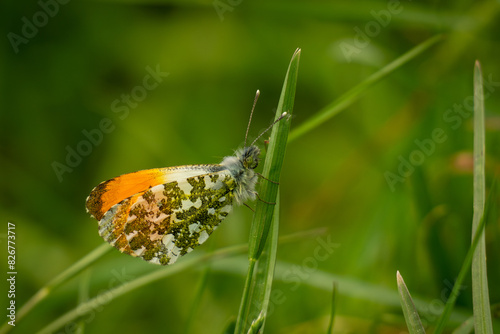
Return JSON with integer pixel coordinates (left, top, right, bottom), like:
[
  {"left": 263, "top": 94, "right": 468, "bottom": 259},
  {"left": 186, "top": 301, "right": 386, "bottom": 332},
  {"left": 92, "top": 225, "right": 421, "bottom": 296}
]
[{"left": 0, "top": 0, "right": 500, "bottom": 333}]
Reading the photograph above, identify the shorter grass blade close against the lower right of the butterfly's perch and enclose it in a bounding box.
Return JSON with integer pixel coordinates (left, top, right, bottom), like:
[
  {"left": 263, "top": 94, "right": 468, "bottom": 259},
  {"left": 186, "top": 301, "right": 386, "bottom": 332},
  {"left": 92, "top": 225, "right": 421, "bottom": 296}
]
[{"left": 248, "top": 190, "right": 280, "bottom": 333}]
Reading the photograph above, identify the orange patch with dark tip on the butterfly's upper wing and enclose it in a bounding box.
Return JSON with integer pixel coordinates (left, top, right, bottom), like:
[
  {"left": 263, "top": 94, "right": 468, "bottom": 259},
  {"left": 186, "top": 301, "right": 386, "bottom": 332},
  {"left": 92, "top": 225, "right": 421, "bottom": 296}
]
[{"left": 85, "top": 168, "right": 171, "bottom": 220}]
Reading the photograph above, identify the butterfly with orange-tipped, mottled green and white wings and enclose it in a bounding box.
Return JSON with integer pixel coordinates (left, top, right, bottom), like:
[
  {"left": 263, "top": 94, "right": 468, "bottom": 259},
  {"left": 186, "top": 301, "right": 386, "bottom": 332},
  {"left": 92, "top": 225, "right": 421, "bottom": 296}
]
[{"left": 86, "top": 91, "right": 286, "bottom": 265}]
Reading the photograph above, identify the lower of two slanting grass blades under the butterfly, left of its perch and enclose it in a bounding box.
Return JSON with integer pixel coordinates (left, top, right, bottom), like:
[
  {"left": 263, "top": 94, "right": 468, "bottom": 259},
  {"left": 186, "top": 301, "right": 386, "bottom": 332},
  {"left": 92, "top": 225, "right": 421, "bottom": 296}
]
[{"left": 38, "top": 245, "right": 247, "bottom": 334}]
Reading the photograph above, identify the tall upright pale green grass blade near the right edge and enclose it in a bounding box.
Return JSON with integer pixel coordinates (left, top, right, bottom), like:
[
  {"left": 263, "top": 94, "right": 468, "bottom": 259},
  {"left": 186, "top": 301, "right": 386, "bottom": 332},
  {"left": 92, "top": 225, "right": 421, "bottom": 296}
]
[{"left": 472, "top": 61, "right": 493, "bottom": 333}]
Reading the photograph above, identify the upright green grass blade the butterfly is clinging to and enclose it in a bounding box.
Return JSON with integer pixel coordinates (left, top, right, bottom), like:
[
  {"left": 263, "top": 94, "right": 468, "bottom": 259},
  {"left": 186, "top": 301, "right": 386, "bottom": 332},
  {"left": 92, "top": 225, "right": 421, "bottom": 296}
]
[{"left": 235, "top": 49, "right": 300, "bottom": 334}]
